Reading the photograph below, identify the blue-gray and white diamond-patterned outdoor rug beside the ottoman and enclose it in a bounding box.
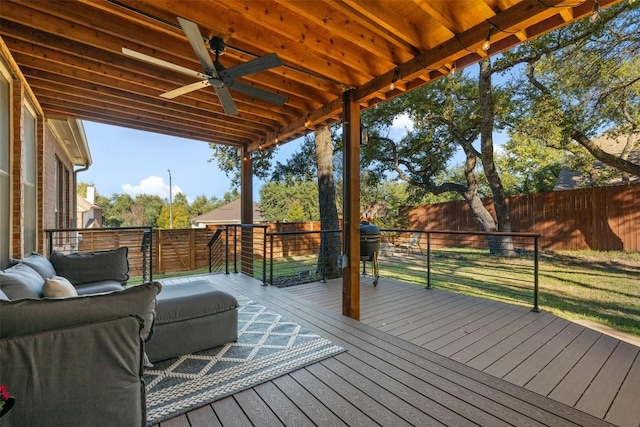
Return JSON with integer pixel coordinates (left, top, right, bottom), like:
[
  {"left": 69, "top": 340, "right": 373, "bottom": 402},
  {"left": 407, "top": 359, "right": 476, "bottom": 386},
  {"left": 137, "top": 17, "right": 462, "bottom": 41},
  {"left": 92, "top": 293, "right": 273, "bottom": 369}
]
[{"left": 144, "top": 296, "right": 344, "bottom": 425}]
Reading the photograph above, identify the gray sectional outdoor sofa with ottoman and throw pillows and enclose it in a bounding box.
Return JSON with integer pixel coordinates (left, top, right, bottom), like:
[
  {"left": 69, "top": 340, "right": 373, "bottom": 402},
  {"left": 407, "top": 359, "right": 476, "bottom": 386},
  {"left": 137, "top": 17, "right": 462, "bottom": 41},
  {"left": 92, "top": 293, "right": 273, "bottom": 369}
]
[{"left": 0, "top": 248, "right": 238, "bottom": 427}]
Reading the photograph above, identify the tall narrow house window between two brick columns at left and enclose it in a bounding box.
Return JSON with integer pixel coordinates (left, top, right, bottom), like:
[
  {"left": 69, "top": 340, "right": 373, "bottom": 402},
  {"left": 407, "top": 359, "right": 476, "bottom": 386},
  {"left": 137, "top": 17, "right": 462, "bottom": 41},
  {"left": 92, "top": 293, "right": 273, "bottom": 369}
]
[{"left": 22, "top": 104, "right": 38, "bottom": 255}]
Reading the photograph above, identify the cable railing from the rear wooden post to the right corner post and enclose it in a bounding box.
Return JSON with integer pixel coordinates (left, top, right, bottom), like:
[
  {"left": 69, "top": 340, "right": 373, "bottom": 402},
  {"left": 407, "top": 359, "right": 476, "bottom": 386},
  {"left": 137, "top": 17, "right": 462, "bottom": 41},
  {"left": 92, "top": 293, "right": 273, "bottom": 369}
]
[{"left": 245, "top": 229, "right": 541, "bottom": 311}]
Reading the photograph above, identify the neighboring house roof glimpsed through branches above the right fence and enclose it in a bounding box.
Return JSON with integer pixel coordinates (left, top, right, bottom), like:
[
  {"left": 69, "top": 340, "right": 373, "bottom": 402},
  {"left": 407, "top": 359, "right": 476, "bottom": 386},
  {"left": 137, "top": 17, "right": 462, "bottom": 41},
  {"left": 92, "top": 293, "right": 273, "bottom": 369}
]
[{"left": 553, "top": 136, "right": 640, "bottom": 191}]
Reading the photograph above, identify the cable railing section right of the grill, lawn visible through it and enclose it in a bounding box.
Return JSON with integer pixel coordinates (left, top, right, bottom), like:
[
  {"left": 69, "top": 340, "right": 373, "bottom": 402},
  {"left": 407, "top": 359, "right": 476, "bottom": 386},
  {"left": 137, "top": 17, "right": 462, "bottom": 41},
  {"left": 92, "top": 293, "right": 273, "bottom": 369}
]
[{"left": 379, "top": 229, "right": 541, "bottom": 311}]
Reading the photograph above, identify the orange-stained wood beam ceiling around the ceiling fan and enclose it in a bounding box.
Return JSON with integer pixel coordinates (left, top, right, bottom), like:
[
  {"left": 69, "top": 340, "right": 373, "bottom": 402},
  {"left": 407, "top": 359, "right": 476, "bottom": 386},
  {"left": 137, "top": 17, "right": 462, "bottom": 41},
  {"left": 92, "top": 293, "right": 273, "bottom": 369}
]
[{"left": 0, "top": 0, "right": 619, "bottom": 150}]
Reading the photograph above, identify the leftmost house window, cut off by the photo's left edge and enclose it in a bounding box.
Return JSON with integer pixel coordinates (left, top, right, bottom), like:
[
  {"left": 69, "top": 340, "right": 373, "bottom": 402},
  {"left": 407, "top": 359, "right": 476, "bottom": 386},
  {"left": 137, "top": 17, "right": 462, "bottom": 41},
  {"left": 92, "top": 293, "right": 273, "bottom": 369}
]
[{"left": 0, "top": 62, "right": 11, "bottom": 266}]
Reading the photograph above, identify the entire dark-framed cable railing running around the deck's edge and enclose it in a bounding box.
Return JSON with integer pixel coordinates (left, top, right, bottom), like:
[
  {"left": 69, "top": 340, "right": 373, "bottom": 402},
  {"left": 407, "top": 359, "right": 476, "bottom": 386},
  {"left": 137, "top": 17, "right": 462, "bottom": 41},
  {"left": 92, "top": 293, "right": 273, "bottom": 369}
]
[{"left": 45, "top": 224, "right": 541, "bottom": 310}]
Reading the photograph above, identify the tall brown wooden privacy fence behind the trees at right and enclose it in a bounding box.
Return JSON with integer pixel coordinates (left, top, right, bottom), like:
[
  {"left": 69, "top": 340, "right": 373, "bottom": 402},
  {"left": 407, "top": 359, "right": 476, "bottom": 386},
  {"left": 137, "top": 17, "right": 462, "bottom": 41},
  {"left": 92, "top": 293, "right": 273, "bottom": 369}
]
[{"left": 405, "top": 184, "right": 640, "bottom": 252}]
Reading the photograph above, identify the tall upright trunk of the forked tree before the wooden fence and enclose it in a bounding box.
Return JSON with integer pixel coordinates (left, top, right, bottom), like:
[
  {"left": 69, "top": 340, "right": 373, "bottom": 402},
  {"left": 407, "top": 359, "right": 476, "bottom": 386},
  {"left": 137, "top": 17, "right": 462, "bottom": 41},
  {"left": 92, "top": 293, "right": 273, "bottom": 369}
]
[{"left": 478, "top": 58, "right": 516, "bottom": 256}]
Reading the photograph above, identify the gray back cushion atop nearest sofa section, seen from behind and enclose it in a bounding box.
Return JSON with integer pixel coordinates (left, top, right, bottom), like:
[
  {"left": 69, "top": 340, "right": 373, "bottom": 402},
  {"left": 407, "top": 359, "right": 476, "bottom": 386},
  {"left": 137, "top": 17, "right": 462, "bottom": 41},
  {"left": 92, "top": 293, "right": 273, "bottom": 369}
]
[{"left": 0, "top": 282, "right": 162, "bottom": 340}]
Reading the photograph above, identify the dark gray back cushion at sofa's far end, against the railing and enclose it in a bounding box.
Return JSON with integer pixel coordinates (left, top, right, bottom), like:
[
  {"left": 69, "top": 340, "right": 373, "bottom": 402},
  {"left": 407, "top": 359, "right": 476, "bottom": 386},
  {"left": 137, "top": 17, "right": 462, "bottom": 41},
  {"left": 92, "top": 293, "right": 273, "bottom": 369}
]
[{"left": 49, "top": 246, "right": 129, "bottom": 285}]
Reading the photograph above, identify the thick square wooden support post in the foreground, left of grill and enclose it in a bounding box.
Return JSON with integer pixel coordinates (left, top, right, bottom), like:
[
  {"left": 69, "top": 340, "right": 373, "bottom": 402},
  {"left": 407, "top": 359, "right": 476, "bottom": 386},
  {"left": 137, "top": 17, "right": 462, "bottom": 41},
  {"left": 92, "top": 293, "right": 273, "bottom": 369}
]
[{"left": 342, "top": 90, "right": 360, "bottom": 320}]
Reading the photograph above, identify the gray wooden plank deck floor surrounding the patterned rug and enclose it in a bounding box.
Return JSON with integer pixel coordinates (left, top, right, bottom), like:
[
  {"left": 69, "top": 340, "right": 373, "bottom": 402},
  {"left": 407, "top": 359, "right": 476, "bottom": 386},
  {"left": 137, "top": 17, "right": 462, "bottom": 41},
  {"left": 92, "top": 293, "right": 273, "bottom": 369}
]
[{"left": 156, "top": 274, "right": 640, "bottom": 427}]
